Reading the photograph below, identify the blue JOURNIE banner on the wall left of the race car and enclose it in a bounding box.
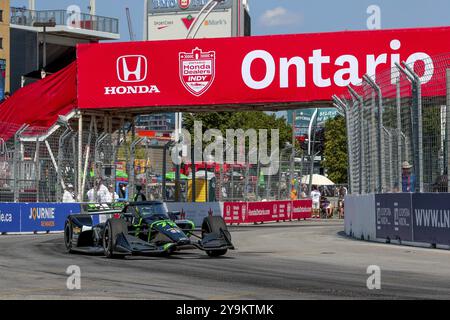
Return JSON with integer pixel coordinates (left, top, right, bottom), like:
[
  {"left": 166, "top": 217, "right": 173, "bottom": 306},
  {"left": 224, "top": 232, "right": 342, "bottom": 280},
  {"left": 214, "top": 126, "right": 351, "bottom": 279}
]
[{"left": 20, "top": 203, "right": 81, "bottom": 232}]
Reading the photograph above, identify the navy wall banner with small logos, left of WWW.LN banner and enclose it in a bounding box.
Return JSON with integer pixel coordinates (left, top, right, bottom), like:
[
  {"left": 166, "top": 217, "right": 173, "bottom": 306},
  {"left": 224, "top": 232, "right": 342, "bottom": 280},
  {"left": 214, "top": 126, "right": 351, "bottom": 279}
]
[{"left": 375, "top": 193, "right": 413, "bottom": 241}]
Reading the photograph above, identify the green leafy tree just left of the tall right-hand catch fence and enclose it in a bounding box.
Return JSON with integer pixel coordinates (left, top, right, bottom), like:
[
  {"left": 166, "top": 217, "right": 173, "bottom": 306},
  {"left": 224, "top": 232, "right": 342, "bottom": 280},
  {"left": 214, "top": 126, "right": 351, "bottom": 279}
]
[{"left": 322, "top": 116, "right": 348, "bottom": 184}]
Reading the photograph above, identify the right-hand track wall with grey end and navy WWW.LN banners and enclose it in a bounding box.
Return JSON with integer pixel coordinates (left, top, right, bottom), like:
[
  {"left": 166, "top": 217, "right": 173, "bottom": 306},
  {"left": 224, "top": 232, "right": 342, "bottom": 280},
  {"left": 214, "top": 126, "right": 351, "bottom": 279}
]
[{"left": 345, "top": 193, "right": 450, "bottom": 249}]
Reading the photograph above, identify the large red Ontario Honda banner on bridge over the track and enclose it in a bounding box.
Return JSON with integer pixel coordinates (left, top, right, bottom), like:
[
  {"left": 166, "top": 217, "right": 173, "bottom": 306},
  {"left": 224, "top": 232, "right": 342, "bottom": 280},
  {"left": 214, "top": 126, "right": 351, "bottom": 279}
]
[{"left": 78, "top": 27, "right": 450, "bottom": 108}]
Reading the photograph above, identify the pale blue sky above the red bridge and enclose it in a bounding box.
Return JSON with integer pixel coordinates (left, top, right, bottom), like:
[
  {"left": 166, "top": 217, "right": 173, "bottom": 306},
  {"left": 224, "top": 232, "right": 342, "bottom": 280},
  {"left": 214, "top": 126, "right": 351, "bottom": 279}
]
[{"left": 11, "top": 0, "right": 450, "bottom": 41}]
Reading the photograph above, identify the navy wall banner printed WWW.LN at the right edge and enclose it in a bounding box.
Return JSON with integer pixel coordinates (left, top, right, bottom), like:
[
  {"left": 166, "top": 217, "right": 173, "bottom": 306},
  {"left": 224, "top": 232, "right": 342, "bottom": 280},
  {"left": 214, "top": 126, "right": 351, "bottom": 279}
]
[{"left": 412, "top": 193, "right": 450, "bottom": 245}]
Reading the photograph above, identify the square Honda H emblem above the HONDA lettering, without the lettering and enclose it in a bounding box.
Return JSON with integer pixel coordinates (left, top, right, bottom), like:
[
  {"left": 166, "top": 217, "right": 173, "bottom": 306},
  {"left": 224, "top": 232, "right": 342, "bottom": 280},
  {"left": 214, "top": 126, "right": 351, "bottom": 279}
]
[{"left": 117, "top": 55, "right": 147, "bottom": 82}]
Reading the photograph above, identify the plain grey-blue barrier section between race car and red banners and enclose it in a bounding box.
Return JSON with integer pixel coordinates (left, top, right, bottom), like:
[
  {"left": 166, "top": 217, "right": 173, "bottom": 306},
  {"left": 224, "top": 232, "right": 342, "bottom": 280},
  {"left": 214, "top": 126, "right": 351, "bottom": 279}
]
[{"left": 167, "top": 202, "right": 223, "bottom": 227}]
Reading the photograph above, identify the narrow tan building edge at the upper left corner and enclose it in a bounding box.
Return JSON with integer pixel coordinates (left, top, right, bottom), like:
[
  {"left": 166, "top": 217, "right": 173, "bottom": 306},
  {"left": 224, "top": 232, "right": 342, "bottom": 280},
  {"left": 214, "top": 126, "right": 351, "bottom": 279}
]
[{"left": 0, "top": 0, "right": 10, "bottom": 99}]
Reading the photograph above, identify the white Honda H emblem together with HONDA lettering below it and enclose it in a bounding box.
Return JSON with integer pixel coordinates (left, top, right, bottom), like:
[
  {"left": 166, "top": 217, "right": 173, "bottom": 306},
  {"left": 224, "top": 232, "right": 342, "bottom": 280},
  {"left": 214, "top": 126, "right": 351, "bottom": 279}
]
[{"left": 105, "top": 55, "right": 160, "bottom": 95}]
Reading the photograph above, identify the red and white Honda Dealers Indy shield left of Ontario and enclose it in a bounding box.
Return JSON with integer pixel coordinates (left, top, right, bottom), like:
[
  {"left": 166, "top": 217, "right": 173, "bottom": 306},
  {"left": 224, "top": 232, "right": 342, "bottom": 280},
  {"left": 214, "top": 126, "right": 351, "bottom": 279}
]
[{"left": 180, "top": 48, "right": 216, "bottom": 97}]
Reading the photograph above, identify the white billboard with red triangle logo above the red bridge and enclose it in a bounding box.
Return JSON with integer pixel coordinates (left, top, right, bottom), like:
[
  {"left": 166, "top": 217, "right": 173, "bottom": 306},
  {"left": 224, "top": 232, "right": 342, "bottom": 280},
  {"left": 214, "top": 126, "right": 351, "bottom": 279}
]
[{"left": 148, "top": 9, "right": 232, "bottom": 40}]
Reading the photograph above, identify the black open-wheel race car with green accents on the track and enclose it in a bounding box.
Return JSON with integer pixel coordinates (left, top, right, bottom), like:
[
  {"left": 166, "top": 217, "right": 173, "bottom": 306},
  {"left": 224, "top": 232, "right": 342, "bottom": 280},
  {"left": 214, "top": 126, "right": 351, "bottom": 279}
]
[{"left": 64, "top": 201, "right": 234, "bottom": 258}]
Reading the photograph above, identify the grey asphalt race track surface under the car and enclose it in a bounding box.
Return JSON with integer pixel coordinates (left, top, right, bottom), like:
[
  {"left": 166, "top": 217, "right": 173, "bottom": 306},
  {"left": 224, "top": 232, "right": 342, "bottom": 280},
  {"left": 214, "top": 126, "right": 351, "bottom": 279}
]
[{"left": 0, "top": 221, "right": 450, "bottom": 300}]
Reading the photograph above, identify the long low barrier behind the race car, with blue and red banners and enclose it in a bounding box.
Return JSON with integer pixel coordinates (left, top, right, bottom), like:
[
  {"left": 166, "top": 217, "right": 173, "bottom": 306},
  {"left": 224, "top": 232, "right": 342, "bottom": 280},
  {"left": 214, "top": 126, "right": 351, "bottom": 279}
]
[{"left": 0, "top": 199, "right": 312, "bottom": 234}]
